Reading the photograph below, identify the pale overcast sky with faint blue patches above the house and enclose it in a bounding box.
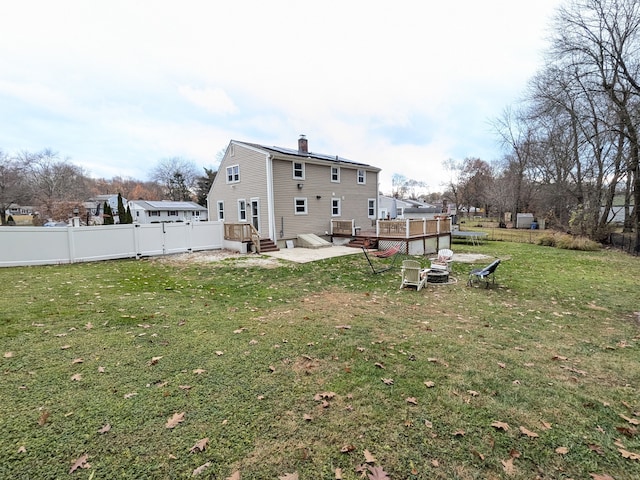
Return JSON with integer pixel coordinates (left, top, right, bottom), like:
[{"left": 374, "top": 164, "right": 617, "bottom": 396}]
[{"left": 0, "top": 0, "right": 562, "bottom": 193}]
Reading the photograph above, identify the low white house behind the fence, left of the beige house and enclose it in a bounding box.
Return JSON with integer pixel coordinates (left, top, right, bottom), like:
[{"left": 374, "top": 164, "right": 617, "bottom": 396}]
[{"left": 128, "top": 200, "right": 208, "bottom": 223}]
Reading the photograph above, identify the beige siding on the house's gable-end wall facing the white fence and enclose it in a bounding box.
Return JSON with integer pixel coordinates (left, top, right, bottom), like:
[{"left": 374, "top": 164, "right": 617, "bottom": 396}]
[{"left": 209, "top": 144, "right": 269, "bottom": 236}]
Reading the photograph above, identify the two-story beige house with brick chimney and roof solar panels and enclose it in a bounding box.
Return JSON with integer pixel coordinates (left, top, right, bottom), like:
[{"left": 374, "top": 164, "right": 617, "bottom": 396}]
[{"left": 207, "top": 135, "right": 380, "bottom": 248}]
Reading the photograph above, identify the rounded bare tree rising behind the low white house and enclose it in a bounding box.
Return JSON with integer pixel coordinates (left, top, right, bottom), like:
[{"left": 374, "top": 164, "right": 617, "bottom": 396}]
[{"left": 151, "top": 157, "right": 199, "bottom": 201}]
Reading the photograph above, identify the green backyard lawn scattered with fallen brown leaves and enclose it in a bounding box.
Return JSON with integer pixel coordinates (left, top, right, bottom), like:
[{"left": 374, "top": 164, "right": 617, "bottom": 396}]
[{"left": 0, "top": 242, "right": 640, "bottom": 480}]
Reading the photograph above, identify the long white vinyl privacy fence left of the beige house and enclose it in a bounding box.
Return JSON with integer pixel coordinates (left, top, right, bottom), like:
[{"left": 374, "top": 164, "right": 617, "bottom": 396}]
[{"left": 0, "top": 222, "right": 224, "bottom": 267}]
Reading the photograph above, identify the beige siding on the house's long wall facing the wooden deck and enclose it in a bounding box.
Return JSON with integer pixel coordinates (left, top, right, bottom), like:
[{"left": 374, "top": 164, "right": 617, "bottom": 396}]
[{"left": 273, "top": 159, "right": 378, "bottom": 240}]
